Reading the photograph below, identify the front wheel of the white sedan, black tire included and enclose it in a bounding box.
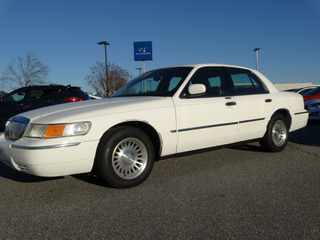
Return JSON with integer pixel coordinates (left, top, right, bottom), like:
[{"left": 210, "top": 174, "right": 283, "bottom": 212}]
[{"left": 96, "top": 127, "right": 155, "bottom": 188}]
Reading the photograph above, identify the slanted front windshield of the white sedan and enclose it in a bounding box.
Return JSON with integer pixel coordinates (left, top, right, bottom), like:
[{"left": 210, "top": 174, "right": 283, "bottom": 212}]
[{"left": 111, "top": 67, "right": 192, "bottom": 97}]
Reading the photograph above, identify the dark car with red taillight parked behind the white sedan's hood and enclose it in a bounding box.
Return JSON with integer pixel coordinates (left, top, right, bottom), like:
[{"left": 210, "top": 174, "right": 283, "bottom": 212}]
[{"left": 0, "top": 85, "right": 90, "bottom": 132}]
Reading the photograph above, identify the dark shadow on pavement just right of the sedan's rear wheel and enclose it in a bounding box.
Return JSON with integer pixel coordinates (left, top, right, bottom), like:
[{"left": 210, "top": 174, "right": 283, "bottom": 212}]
[{"left": 289, "top": 121, "right": 320, "bottom": 147}]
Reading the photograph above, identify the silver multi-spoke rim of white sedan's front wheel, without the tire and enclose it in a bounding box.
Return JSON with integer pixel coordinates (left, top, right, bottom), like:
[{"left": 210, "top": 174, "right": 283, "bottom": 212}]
[{"left": 112, "top": 138, "right": 148, "bottom": 179}]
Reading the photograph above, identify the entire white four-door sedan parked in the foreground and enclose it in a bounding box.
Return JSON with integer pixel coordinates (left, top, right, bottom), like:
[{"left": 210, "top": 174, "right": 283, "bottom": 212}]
[{"left": 0, "top": 64, "right": 308, "bottom": 188}]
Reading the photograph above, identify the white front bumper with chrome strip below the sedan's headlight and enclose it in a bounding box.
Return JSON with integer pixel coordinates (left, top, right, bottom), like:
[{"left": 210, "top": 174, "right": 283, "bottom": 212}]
[{"left": 0, "top": 134, "right": 98, "bottom": 177}]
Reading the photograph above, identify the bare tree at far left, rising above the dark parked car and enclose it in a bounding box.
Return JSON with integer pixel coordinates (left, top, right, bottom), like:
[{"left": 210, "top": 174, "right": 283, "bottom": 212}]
[{"left": 0, "top": 51, "right": 49, "bottom": 88}]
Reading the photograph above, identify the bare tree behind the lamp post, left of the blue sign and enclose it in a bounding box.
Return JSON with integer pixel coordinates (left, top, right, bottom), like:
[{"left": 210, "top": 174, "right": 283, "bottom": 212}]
[{"left": 85, "top": 62, "right": 132, "bottom": 97}]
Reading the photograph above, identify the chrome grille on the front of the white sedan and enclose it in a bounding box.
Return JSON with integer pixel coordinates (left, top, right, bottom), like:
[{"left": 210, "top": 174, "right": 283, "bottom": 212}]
[{"left": 5, "top": 116, "right": 30, "bottom": 140}]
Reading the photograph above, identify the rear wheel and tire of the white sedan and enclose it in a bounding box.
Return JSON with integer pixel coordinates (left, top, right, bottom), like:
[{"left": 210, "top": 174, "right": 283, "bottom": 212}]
[{"left": 260, "top": 114, "right": 289, "bottom": 152}]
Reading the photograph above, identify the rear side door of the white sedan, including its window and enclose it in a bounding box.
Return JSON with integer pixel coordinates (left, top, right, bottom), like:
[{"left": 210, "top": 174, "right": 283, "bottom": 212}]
[{"left": 226, "top": 68, "right": 275, "bottom": 141}]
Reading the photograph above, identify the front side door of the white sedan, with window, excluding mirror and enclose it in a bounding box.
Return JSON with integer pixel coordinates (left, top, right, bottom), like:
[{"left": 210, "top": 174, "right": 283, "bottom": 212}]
[{"left": 173, "top": 67, "right": 238, "bottom": 152}]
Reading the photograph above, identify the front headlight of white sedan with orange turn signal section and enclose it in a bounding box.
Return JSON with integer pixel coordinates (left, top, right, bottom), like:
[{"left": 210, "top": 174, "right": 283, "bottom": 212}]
[{"left": 23, "top": 122, "right": 91, "bottom": 138}]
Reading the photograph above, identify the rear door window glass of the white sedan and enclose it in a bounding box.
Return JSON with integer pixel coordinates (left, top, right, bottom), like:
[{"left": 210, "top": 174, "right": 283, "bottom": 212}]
[{"left": 228, "top": 68, "right": 268, "bottom": 95}]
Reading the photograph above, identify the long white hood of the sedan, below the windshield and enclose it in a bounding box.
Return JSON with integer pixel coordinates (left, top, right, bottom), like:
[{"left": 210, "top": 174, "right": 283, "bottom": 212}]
[{"left": 20, "top": 97, "right": 173, "bottom": 124}]
